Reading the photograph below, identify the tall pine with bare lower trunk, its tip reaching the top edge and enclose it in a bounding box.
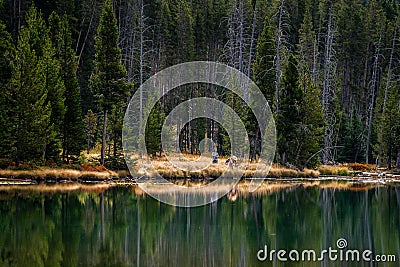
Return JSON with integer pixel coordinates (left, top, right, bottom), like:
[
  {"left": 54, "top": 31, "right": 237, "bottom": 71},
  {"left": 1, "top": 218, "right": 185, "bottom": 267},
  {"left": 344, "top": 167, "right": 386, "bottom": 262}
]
[{"left": 90, "top": 0, "right": 130, "bottom": 164}]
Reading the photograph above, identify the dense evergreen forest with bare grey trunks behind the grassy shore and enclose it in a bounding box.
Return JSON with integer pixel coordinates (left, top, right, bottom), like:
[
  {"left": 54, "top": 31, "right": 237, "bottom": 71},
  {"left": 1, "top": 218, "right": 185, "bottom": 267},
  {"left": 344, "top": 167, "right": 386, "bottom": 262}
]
[{"left": 0, "top": 0, "right": 400, "bottom": 171}]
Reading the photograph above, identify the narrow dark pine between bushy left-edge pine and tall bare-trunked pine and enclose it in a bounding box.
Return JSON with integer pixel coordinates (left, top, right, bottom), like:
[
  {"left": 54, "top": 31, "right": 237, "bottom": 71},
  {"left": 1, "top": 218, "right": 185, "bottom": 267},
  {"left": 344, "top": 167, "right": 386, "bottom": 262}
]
[{"left": 49, "top": 12, "right": 84, "bottom": 161}]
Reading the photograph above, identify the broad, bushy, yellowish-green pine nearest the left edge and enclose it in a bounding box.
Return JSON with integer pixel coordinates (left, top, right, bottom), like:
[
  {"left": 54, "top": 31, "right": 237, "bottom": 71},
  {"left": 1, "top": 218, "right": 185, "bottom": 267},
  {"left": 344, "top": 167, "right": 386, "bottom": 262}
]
[{"left": 5, "top": 19, "right": 53, "bottom": 165}]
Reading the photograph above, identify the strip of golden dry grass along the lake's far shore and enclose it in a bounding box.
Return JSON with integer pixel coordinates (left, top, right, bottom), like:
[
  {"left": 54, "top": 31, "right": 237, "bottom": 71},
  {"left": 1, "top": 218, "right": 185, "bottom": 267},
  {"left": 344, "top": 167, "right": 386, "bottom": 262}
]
[{"left": 0, "top": 155, "right": 349, "bottom": 183}]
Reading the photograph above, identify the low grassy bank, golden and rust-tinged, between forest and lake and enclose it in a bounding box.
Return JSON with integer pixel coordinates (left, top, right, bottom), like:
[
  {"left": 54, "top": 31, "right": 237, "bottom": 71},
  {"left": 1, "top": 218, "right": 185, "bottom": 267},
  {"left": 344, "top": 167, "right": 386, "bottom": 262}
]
[{"left": 0, "top": 157, "right": 397, "bottom": 183}]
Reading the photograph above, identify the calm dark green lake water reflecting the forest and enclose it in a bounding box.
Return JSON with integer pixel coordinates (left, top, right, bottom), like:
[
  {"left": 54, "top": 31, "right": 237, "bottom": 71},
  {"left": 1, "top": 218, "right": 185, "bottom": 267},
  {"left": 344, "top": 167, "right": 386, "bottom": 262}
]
[{"left": 0, "top": 186, "right": 400, "bottom": 266}]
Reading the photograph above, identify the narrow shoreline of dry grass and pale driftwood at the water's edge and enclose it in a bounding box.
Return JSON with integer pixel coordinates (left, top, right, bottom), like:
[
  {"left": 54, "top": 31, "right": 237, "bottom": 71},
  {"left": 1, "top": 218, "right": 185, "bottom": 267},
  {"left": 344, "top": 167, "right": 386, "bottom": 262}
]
[{"left": 0, "top": 164, "right": 400, "bottom": 185}]
